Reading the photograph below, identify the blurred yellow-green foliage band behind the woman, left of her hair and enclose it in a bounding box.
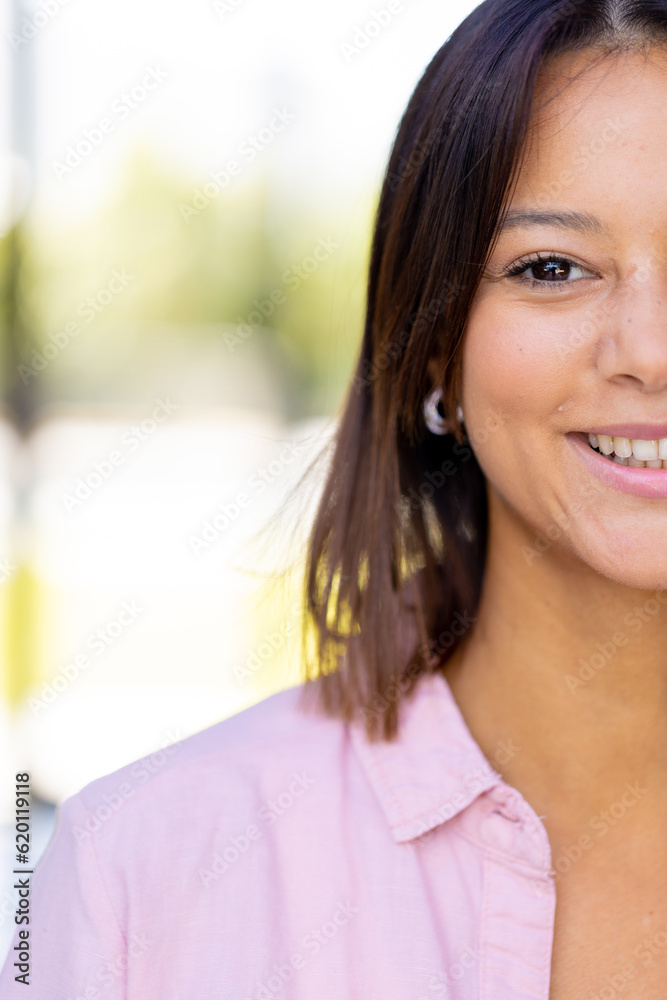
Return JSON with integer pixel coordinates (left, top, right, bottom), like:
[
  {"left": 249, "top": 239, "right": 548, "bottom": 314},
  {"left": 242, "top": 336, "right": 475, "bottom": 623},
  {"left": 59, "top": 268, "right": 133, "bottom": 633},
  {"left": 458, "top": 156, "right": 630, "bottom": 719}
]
[{"left": 11, "top": 147, "right": 376, "bottom": 419}]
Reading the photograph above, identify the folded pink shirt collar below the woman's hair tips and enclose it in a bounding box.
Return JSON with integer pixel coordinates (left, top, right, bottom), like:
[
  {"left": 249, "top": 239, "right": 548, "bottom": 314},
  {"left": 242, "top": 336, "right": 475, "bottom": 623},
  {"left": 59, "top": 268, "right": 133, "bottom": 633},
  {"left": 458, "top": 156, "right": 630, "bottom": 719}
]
[{"left": 350, "top": 673, "right": 502, "bottom": 843}]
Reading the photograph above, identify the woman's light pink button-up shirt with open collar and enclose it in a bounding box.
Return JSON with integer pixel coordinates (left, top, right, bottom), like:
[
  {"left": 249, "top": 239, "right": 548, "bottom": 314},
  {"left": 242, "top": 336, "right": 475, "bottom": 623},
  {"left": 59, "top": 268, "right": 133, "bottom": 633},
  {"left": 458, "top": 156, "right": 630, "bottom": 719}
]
[{"left": 0, "top": 674, "right": 556, "bottom": 1000}]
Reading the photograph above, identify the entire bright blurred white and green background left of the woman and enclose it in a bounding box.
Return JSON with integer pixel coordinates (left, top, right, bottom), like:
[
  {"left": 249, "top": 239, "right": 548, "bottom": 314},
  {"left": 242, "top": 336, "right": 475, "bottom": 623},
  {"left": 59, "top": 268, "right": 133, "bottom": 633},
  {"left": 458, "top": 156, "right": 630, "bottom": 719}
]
[{"left": 0, "top": 0, "right": 476, "bottom": 958}]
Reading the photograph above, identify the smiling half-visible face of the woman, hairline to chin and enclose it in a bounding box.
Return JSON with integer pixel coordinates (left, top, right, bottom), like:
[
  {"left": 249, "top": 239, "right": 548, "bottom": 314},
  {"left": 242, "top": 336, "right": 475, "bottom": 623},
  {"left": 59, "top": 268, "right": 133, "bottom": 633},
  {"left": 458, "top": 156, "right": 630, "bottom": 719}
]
[{"left": 461, "top": 49, "right": 667, "bottom": 589}]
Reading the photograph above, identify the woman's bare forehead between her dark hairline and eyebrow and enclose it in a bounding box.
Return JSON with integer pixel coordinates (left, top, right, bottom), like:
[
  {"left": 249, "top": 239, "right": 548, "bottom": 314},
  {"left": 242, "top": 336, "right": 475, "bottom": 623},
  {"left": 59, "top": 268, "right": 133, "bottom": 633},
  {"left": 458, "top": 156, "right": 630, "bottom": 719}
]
[{"left": 504, "top": 46, "right": 667, "bottom": 225}]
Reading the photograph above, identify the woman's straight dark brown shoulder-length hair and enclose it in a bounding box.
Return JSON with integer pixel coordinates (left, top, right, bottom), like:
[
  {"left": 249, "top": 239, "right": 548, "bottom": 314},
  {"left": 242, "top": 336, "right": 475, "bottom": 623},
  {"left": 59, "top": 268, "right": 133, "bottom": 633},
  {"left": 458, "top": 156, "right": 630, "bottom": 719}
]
[{"left": 302, "top": 0, "right": 667, "bottom": 740}]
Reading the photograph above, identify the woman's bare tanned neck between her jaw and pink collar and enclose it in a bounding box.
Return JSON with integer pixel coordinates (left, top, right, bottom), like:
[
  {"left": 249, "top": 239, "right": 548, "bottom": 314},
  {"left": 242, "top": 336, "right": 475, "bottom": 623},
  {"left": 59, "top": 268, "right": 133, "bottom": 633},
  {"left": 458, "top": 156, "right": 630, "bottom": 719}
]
[{"left": 444, "top": 495, "right": 667, "bottom": 829}]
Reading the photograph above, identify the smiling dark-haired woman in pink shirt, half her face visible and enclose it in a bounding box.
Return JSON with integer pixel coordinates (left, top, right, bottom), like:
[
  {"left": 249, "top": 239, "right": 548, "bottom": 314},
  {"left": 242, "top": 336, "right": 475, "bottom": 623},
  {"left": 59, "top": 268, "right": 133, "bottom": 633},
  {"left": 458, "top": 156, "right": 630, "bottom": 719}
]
[{"left": 5, "top": 0, "right": 667, "bottom": 1000}]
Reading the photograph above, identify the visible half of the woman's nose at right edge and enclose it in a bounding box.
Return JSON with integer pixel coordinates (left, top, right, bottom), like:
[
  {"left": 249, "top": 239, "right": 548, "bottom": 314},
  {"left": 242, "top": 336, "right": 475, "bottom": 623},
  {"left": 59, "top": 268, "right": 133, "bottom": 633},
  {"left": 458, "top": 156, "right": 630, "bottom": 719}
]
[{"left": 596, "top": 263, "right": 667, "bottom": 394}]
